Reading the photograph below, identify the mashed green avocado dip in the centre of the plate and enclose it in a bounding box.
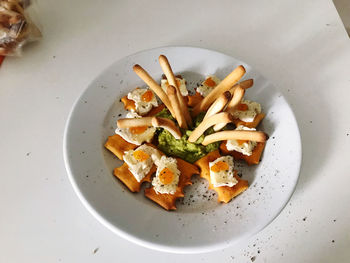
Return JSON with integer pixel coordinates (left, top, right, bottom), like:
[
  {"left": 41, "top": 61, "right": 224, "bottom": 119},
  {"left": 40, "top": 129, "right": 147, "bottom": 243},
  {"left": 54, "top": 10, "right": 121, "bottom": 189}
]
[{"left": 156, "top": 109, "right": 220, "bottom": 163}]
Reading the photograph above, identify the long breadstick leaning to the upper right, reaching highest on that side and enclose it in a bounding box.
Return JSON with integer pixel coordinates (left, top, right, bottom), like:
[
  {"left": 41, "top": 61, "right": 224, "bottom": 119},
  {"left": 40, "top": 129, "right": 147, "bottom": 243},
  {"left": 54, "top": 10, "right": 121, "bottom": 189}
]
[{"left": 193, "top": 65, "right": 245, "bottom": 116}]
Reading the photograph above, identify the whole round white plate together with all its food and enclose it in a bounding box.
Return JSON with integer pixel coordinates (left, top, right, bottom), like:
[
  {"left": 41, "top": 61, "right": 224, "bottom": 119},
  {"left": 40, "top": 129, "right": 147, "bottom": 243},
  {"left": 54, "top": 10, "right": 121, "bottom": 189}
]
[{"left": 63, "top": 47, "right": 301, "bottom": 253}]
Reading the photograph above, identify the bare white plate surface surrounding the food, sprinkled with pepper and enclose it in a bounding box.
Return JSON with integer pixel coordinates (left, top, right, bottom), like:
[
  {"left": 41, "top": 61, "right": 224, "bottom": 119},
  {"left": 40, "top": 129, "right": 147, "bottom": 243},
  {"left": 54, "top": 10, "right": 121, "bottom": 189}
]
[{"left": 64, "top": 47, "right": 301, "bottom": 253}]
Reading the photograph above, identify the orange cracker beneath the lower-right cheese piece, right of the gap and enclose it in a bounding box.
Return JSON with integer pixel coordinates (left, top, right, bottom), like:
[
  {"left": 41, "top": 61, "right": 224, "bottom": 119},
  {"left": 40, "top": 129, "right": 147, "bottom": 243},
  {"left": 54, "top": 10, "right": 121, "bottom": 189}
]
[{"left": 195, "top": 150, "right": 248, "bottom": 203}]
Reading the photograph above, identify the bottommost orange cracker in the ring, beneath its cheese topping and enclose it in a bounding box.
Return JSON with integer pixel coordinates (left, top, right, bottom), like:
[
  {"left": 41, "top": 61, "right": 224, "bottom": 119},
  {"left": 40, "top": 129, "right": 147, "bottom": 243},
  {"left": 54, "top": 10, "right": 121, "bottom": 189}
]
[{"left": 145, "top": 158, "right": 199, "bottom": 210}]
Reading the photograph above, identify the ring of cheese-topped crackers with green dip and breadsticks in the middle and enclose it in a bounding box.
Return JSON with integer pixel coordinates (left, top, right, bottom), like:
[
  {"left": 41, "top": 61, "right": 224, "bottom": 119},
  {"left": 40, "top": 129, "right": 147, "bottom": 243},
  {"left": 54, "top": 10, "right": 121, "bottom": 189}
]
[{"left": 105, "top": 55, "right": 267, "bottom": 210}]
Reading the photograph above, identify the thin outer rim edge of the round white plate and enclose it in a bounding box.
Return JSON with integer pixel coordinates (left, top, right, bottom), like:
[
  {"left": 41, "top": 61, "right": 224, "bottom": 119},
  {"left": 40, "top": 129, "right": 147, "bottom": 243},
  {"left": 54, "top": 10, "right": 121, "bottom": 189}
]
[{"left": 62, "top": 45, "right": 303, "bottom": 254}]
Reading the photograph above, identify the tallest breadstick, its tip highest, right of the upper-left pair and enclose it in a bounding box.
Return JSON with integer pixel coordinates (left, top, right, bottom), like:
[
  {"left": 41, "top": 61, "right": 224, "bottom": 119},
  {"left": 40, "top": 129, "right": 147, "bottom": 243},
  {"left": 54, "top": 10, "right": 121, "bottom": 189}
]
[{"left": 158, "top": 55, "right": 192, "bottom": 126}]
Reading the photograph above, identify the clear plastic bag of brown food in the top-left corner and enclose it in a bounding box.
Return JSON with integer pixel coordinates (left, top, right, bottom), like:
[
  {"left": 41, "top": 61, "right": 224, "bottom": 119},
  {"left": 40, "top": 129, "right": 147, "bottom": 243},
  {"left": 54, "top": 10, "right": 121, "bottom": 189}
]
[{"left": 0, "top": 0, "right": 41, "bottom": 56}]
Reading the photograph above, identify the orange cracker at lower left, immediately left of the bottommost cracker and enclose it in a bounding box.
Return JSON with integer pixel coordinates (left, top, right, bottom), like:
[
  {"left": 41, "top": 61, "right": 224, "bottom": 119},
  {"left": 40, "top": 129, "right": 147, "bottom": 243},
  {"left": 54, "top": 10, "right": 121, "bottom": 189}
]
[{"left": 114, "top": 163, "right": 157, "bottom": 193}]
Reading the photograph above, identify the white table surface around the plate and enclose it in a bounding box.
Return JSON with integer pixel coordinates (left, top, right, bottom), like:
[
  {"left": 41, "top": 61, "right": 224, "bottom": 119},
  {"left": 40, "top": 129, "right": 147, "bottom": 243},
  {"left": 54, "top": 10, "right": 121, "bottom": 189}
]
[{"left": 0, "top": 0, "right": 350, "bottom": 262}]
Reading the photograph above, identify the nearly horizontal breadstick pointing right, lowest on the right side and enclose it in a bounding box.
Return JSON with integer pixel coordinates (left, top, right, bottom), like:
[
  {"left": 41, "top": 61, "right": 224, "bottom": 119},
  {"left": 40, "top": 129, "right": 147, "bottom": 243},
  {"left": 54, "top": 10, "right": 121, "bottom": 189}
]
[{"left": 202, "top": 131, "right": 267, "bottom": 145}]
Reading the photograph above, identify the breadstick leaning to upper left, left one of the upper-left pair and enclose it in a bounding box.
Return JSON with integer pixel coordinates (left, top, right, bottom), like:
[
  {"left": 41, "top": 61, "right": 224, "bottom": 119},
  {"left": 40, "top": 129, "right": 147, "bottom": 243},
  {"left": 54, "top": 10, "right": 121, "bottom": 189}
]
[{"left": 133, "top": 64, "right": 175, "bottom": 118}]
